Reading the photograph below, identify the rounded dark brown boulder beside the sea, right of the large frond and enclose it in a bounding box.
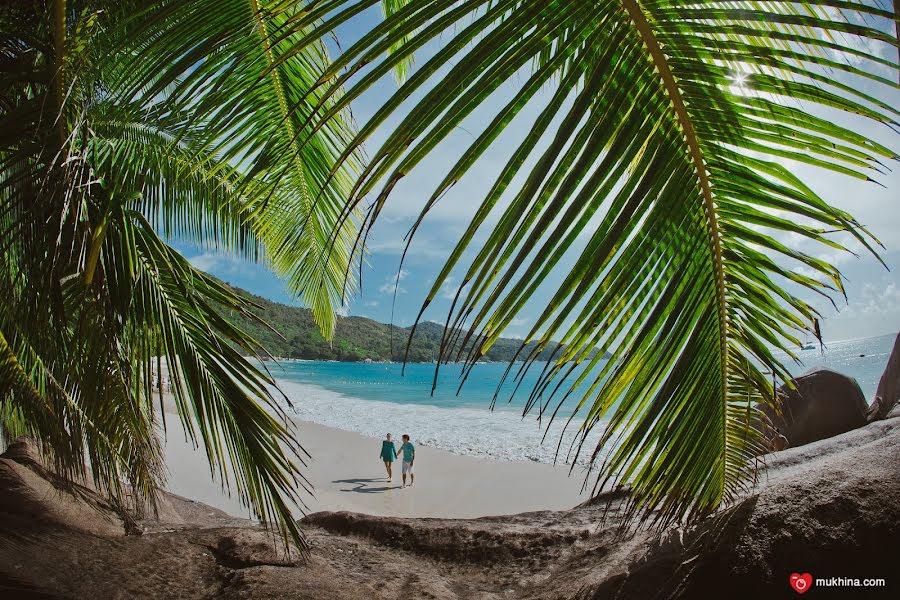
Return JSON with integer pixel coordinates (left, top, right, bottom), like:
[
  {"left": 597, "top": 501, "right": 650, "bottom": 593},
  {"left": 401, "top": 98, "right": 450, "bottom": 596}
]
[{"left": 759, "top": 369, "right": 869, "bottom": 447}]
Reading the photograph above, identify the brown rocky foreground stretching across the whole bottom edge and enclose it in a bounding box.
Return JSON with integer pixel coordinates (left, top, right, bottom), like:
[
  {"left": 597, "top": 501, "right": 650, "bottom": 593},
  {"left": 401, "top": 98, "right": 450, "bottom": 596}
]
[{"left": 0, "top": 411, "right": 900, "bottom": 600}]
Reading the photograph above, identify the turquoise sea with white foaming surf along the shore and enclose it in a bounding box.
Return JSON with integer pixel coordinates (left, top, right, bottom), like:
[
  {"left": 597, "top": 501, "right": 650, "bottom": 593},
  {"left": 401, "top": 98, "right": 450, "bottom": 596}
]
[{"left": 269, "top": 334, "right": 895, "bottom": 464}]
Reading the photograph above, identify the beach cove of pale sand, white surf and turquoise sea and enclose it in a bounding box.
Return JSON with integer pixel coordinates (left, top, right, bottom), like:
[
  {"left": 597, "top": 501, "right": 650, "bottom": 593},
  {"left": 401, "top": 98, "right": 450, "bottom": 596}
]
[{"left": 165, "top": 335, "right": 895, "bottom": 518}]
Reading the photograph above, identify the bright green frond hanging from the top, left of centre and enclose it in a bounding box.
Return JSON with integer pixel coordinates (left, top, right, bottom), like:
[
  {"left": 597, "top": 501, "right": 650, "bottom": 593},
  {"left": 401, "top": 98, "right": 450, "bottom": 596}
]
[{"left": 115, "top": 0, "right": 359, "bottom": 337}]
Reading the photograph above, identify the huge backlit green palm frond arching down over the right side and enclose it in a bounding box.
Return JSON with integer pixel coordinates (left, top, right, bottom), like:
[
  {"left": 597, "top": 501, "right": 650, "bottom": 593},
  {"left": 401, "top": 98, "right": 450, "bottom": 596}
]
[{"left": 296, "top": 0, "right": 900, "bottom": 523}]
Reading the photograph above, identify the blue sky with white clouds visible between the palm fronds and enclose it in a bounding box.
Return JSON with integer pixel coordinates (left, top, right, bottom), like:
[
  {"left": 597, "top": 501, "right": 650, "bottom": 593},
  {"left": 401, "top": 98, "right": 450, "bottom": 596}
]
[{"left": 178, "top": 3, "right": 900, "bottom": 340}]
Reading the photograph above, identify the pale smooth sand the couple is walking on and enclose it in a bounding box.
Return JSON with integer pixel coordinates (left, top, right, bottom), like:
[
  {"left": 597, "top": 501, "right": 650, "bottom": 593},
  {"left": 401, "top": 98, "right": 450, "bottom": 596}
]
[{"left": 158, "top": 394, "right": 587, "bottom": 518}]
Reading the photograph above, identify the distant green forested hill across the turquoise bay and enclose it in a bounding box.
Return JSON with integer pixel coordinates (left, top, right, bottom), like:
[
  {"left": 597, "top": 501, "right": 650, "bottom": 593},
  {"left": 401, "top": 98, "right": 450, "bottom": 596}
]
[{"left": 225, "top": 288, "right": 612, "bottom": 362}]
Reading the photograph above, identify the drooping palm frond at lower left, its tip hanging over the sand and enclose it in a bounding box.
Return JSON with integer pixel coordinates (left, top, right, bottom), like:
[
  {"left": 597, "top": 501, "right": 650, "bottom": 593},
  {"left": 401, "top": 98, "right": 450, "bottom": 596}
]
[{"left": 112, "top": 211, "right": 311, "bottom": 547}]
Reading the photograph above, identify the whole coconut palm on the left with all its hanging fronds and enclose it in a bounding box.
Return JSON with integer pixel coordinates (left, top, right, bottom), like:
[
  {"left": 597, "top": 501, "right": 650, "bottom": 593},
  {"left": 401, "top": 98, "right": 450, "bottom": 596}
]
[{"left": 0, "top": 0, "right": 358, "bottom": 543}]
